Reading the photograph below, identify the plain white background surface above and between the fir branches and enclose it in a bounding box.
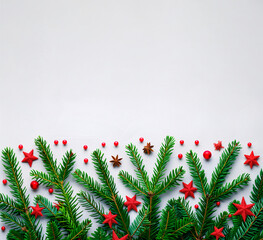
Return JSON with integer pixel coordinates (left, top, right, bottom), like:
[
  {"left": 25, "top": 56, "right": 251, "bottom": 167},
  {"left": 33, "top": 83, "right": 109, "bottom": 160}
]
[{"left": 0, "top": 0, "right": 263, "bottom": 238}]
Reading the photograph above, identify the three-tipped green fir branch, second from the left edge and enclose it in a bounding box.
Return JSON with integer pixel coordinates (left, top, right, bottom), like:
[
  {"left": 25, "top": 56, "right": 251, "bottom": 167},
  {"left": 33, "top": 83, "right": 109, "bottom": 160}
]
[{"left": 30, "top": 137, "right": 91, "bottom": 239}]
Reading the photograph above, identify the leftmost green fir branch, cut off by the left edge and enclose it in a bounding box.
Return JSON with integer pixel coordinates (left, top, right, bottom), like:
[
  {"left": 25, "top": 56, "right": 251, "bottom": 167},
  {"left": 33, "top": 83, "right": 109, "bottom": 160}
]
[{"left": 0, "top": 148, "right": 42, "bottom": 240}]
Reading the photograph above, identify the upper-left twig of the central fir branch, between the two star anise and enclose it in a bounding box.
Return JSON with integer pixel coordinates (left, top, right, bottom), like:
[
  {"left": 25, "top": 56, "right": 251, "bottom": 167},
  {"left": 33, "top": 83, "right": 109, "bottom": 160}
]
[{"left": 126, "top": 143, "right": 150, "bottom": 192}]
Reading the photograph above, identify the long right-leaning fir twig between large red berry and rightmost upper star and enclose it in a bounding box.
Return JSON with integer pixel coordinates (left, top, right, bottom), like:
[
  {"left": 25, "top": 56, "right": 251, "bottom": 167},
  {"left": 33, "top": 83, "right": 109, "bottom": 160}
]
[{"left": 209, "top": 140, "right": 241, "bottom": 195}]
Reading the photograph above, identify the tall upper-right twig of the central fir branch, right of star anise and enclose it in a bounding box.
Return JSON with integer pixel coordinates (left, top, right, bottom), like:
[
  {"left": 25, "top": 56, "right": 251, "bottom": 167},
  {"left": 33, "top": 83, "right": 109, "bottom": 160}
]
[{"left": 151, "top": 136, "right": 175, "bottom": 191}]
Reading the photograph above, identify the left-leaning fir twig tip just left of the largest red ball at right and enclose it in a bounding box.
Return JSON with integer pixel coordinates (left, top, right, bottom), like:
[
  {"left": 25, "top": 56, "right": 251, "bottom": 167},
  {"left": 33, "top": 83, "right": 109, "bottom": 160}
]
[{"left": 186, "top": 150, "right": 208, "bottom": 196}]
